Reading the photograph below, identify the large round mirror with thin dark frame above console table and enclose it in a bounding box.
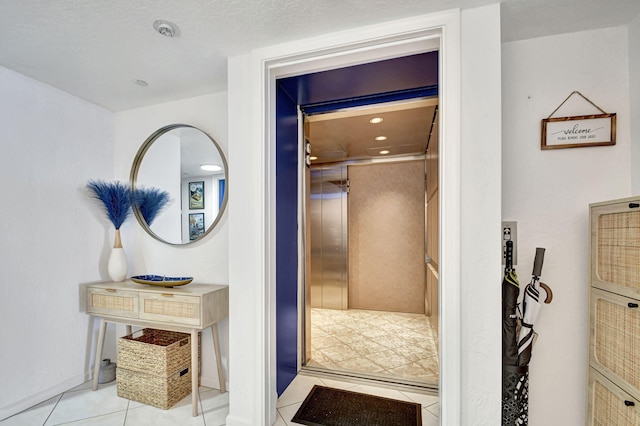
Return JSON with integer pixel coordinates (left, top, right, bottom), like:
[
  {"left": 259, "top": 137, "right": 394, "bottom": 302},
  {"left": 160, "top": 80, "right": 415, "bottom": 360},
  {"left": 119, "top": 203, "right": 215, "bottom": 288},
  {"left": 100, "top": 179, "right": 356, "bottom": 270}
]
[{"left": 130, "top": 124, "right": 228, "bottom": 245}]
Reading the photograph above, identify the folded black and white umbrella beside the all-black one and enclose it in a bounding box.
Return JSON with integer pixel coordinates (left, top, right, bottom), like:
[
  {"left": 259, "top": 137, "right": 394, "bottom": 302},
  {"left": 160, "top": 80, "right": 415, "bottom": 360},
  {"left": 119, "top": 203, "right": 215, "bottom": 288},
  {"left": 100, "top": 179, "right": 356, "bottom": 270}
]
[{"left": 518, "top": 247, "right": 553, "bottom": 366}]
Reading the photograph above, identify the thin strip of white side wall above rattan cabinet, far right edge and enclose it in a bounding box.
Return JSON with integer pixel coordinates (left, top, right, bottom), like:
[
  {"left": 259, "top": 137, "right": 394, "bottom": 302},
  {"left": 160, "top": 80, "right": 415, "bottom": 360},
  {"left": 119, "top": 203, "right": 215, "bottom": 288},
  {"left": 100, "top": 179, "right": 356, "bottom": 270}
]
[{"left": 628, "top": 15, "right": 640, "bottom": 191}]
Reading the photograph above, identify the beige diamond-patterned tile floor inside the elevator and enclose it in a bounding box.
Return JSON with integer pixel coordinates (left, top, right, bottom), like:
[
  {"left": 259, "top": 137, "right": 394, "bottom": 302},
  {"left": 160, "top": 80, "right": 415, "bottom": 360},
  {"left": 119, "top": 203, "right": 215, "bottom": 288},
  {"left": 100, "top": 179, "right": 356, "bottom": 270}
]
[{"left": 307, "top": 308, "right": 439, "bottom": 385}]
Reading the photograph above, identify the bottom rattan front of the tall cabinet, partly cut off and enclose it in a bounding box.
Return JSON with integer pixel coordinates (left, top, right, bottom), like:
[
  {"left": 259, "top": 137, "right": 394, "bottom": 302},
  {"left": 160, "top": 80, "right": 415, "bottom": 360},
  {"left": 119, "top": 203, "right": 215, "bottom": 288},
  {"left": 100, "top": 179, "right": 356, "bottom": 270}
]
[{"left": 587, "top": 368, "right": 640, "bottom": 426}]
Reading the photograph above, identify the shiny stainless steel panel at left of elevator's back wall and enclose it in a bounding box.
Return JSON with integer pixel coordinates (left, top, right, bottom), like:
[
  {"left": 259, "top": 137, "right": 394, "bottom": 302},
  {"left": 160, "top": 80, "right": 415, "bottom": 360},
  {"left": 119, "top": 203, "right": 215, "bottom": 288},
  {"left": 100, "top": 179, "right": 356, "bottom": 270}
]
[{"left": 310, "top": 165, "right": 349, "bottom": 309}]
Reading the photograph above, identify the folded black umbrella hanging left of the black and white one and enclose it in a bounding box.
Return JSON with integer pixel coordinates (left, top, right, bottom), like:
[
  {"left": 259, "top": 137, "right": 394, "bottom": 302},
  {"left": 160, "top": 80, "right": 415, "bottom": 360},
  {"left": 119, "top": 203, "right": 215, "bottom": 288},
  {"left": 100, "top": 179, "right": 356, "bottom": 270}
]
[{"left": 502, "top": 240, "right": 520, "bottom": 365}]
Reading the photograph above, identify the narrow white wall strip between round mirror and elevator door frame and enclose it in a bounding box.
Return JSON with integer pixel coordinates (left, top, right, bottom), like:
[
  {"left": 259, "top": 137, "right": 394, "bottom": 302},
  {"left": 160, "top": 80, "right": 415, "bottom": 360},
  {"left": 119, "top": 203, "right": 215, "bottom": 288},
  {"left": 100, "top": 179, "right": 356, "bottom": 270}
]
[{"left": 227, "top": 55, "right": 264, "bottom": 426}]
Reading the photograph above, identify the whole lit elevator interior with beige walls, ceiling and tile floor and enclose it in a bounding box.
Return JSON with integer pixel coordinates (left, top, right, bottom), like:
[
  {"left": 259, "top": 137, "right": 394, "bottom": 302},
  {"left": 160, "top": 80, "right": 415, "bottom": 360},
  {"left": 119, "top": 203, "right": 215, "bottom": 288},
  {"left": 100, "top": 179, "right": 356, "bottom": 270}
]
[{"left": 302, "top": 98, "right": 438, "bottom": 387}]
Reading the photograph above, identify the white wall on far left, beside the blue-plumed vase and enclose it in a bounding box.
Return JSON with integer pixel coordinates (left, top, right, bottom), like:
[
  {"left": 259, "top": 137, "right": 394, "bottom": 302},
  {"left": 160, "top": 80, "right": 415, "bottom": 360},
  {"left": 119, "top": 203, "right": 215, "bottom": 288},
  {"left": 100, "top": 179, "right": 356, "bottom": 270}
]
[{"left": 0, "top": 67, "right": 114, "bottom": 419}]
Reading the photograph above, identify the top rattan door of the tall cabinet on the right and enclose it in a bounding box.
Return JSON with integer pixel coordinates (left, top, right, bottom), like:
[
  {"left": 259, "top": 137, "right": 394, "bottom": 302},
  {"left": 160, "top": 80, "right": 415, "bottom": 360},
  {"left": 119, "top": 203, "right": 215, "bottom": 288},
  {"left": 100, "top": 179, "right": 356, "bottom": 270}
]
[{"left": 590, "top": 198, "right": 640, "bottom": 299}]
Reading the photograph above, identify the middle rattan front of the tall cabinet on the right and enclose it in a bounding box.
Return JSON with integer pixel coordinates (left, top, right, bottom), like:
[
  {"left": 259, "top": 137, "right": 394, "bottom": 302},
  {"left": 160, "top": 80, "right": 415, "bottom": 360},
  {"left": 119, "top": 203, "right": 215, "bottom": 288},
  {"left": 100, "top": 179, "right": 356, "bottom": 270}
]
[{"left": 590, "top": 289, "right": 640, "bottom": 399}]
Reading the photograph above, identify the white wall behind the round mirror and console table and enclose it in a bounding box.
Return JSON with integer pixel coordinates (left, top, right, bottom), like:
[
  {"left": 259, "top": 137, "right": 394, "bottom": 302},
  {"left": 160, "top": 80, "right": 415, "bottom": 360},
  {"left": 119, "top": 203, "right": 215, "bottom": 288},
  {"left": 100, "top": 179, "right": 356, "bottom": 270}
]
[{"left": 112, "top": 92, "right": 234, "bottom": 388}]
